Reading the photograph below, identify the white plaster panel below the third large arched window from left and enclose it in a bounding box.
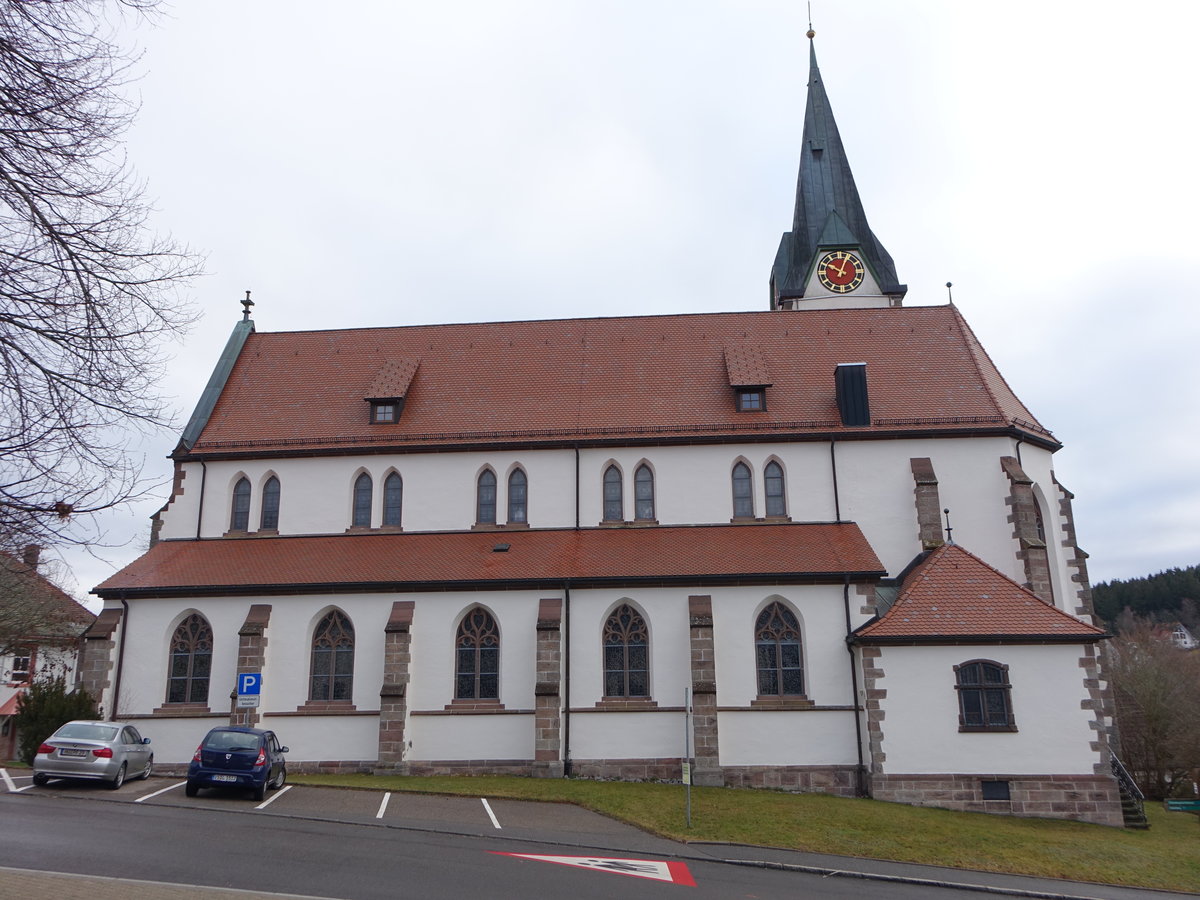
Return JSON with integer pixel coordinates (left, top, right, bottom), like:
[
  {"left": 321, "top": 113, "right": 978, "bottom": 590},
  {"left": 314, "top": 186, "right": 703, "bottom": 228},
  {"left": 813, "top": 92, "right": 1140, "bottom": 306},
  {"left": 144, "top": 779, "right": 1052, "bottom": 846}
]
[{"left": 406, "top": 713, "right": 534, "bottom": 762}]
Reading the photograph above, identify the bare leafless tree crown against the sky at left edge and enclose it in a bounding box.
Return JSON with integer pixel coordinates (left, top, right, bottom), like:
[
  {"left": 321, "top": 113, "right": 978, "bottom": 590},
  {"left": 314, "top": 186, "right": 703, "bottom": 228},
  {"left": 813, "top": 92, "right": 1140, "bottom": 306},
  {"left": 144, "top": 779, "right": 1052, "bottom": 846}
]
[{"left": 0, "top": 0, "right": 199, "bottom": 551}]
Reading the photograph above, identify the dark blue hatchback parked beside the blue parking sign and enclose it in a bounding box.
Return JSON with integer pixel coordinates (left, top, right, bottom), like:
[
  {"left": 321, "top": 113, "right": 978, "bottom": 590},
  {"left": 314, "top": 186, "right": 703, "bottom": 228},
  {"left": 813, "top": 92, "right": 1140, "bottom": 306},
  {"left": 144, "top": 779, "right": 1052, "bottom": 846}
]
[{"left": 184, "top": 725, "right": 288, "bottom": 800}]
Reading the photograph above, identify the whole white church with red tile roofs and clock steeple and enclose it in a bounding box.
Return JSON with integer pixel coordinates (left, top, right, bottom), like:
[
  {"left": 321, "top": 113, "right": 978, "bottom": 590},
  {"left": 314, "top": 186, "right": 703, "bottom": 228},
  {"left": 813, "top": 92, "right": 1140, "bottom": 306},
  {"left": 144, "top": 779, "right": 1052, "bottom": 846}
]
[{"left": 85, "top": 35, "right": 1122, "bottom": 826}]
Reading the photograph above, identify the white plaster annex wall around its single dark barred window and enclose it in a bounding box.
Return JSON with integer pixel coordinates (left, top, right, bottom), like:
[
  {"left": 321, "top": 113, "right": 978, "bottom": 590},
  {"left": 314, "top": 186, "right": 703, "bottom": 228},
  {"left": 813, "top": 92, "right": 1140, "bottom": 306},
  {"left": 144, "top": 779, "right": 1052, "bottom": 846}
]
[{"left": 873, "top": 644, "right": 1099, "bottom": 775}]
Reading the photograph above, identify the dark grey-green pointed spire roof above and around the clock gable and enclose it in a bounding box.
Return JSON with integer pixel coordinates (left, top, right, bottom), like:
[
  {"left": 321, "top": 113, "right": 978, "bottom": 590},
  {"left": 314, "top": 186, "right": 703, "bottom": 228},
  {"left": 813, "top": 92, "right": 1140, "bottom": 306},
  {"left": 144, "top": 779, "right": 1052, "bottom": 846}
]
[{"left": 772, "top": 41, "right": 906, "bottom": 300}]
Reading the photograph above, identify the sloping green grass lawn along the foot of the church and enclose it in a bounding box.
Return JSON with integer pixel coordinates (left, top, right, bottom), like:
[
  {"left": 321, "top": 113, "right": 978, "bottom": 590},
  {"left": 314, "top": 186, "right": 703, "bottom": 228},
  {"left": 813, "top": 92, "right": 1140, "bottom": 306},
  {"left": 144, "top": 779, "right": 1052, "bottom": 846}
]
[{"left": 292, "top": 775, "right": 1200, "bottom": 892}]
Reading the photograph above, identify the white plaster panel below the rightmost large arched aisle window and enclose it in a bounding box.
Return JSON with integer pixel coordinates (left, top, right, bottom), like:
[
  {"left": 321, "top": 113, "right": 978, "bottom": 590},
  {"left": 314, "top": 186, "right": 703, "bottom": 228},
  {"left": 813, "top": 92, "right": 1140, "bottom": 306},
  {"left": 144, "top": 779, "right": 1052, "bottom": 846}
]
[{"left": 716, "top": 710, "right": 858, "bottom": 766}]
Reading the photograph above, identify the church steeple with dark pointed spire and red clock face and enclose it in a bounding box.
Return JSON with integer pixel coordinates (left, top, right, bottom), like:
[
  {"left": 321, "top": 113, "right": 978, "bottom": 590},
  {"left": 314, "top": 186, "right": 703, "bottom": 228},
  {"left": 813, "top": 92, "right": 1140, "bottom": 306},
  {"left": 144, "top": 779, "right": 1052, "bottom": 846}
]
[{"left": 770, "top": 36, "right": 907, "bottom": 308}]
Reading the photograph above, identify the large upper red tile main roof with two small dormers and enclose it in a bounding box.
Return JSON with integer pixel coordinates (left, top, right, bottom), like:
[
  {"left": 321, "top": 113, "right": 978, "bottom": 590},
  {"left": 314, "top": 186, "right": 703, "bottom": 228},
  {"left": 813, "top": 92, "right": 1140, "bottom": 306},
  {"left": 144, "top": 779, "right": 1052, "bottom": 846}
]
[{"left": 184, "top": 306, "right": 1056, "bottom": 456}]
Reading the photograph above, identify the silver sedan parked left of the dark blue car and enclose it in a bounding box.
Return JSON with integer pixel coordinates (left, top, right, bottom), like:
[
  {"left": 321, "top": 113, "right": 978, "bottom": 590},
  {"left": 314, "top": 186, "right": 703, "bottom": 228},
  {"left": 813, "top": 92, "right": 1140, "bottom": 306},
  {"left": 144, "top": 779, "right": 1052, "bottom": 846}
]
[{"left": 34, "top": 721, "right": 154, "bottom": 791}]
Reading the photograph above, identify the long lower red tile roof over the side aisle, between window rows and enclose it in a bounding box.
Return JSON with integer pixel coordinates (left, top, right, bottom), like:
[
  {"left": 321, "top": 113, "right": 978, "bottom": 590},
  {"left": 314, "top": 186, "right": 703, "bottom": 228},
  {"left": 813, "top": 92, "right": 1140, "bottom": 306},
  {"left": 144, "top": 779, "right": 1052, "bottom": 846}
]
[{"left": 94, "top": 523, "right": 883, "bottom": 596}]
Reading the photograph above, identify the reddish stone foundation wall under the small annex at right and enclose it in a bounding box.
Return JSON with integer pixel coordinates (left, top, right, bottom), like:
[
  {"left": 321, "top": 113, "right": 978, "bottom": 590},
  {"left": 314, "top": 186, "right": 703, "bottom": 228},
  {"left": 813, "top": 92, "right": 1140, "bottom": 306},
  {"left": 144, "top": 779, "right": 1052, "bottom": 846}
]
[{"left": 871, "top": 774, "right": 1124, "bottom": 828}]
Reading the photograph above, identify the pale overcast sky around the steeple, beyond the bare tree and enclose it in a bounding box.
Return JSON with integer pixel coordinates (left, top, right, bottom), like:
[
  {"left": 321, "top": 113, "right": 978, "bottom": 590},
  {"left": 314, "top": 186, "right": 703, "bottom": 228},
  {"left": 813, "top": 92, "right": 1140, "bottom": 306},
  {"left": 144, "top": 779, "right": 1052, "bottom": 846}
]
[{"left": 49, "top": 0, "right": 1200, "bottom": 606}]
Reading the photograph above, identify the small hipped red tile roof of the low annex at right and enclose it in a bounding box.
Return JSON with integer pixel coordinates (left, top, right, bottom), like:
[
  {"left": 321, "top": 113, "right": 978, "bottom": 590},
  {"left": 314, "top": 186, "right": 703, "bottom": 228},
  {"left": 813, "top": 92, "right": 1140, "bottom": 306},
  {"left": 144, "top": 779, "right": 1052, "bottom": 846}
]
[{"left": 856, "top": 544, "right": 1105, "bottom": 644}]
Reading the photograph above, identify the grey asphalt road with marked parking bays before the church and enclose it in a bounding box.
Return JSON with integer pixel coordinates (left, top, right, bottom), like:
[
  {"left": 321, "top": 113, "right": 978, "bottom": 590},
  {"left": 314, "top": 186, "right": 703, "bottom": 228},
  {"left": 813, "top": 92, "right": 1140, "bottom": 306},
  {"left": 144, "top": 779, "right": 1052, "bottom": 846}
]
[{"left": 0, "top": 778, "right": 1180, "bottom": 900}]
